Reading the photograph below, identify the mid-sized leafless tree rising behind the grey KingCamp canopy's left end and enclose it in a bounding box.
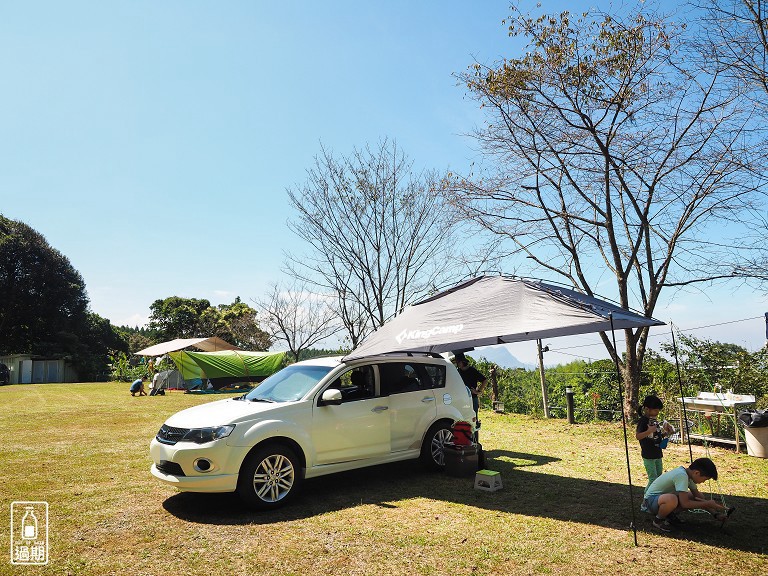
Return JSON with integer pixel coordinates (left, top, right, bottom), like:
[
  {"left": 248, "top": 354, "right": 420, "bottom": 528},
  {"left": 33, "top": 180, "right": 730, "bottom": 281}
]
[{"left": 288, "top": 139, "right": 455, "bottom": 348}]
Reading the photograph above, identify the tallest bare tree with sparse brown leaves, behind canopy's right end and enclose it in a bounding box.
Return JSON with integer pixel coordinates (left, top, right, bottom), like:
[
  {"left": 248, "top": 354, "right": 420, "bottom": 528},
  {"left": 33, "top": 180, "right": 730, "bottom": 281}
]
[{"left": 449, "top": 7, "right": 765, "bottom": 413}]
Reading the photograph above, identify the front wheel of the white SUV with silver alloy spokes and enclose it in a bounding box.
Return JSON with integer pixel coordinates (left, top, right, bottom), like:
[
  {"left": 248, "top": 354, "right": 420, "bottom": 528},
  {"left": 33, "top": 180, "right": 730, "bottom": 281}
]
[{"left": 237, "top": 444, "right": 303, "bottom": 510}]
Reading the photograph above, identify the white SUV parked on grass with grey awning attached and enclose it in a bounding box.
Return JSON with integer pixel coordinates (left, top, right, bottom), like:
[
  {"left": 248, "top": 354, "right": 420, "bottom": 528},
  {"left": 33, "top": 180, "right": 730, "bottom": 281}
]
[{"left": 150, "top": 355, "right": 475, "bottom": 509}]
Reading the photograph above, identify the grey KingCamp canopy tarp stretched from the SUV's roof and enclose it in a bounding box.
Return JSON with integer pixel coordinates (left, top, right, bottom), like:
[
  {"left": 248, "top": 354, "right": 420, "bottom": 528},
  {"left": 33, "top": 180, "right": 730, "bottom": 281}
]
[{"left": 345, "top": 276, "right": 664, "bottom": 359}]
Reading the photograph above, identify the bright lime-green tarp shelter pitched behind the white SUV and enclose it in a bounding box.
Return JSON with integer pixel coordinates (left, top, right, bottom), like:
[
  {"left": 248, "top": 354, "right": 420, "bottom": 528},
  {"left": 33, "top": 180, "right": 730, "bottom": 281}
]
[{"left": 169, "top": 350, "right": 285, "bottom": 390}]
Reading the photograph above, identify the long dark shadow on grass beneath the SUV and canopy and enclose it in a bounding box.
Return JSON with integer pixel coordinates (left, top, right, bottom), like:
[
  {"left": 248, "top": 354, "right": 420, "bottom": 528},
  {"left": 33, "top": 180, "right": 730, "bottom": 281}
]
[{"left": 163, "top": 450, "right": 768, "bottom": 554}]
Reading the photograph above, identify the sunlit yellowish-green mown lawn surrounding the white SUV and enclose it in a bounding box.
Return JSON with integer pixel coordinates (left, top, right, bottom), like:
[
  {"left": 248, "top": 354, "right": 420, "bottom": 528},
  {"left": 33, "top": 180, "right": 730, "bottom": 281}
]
[{"left": 0, "top": 383, "right": 768, "bottom": 576}]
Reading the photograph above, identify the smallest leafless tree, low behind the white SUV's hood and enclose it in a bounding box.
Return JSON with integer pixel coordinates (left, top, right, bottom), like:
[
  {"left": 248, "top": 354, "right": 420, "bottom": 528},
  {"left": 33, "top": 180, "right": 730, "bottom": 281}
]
[{"left": 256, "top": 283, "right": 340, "bottom": 362}]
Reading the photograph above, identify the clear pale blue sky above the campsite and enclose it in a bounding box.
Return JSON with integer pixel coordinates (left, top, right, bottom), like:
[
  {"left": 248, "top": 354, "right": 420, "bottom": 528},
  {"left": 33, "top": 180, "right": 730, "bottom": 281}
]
[{"left": 0, "top": 0, "right": 768, "bottom": 362}]
